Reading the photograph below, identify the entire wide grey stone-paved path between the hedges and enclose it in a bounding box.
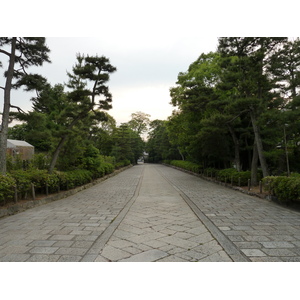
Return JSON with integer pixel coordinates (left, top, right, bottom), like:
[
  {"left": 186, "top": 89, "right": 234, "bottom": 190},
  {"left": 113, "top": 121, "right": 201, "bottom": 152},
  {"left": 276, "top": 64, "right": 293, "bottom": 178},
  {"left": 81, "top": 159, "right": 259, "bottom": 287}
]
[{"left": 0, "top": 164, "right": 300, "bottom": 262}]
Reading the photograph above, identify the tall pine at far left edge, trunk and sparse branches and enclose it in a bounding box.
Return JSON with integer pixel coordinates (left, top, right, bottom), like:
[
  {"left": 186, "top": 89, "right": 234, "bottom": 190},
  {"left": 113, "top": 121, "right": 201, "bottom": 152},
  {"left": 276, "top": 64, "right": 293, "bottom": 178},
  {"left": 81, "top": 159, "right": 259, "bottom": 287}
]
[{"left": 0, "top": 37, "right": 50, "bottom": 174}]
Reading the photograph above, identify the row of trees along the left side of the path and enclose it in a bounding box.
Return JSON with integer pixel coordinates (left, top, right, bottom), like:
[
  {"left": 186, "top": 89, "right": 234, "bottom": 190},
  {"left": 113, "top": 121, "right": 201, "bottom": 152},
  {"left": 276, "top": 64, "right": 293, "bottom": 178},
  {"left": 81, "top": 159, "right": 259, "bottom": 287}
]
[{"left": 0, "top": 38, "right": 145, "bottom": 175}]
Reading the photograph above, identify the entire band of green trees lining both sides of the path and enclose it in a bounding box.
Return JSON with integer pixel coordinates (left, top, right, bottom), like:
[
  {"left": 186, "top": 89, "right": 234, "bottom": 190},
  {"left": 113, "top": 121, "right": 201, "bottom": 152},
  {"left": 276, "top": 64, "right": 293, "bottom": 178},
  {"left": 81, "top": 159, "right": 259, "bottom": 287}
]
[{"left": 0, "top": 37, "right": 300, "bottom": 182}]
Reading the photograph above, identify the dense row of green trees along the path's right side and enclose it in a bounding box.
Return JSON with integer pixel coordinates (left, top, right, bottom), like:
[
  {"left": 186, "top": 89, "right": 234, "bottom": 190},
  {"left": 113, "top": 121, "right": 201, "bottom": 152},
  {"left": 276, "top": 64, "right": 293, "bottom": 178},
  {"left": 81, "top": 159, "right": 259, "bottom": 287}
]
[{"left": 148, "top": 37, "right": 300, "bottom": 184}]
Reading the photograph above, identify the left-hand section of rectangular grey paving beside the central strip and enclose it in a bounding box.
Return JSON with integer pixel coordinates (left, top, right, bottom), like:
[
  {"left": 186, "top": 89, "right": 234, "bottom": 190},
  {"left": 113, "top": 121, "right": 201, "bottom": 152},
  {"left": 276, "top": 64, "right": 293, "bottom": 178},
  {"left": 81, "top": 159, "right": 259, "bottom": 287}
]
[{"left": 0, "top": 168, "right": 142, "bottom": 262}]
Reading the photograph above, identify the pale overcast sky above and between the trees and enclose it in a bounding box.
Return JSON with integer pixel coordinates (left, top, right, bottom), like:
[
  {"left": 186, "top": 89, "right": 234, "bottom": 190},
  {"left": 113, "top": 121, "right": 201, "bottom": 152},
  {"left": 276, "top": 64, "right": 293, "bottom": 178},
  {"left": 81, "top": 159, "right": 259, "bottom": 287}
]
[{"left": 24, "top": 36, "right": 217, "bottom": 123}]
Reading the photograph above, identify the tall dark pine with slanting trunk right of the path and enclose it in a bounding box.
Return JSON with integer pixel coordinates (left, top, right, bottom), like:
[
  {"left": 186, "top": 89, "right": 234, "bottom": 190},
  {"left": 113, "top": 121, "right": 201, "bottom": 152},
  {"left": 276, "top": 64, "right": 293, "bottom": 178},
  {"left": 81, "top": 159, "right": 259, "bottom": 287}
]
[{"left": 218, "top": 37, "right": 287, "bottom": 177}]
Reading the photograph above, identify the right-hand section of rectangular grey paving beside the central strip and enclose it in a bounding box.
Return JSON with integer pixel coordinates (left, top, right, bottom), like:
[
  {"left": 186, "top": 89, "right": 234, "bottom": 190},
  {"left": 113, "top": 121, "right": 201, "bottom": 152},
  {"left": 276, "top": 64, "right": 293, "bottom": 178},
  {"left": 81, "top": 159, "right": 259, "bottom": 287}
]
[{"left": 160, "top": 166, "right": 300, "bottom": 262}]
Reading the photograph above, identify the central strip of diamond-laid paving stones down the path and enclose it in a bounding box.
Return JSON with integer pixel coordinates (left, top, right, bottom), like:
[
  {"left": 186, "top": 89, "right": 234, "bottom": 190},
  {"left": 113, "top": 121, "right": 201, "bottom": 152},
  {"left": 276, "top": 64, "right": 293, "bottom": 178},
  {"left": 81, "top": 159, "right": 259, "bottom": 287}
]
[{"left": 95, "top": 165, "right": 232, "bottom": 262}]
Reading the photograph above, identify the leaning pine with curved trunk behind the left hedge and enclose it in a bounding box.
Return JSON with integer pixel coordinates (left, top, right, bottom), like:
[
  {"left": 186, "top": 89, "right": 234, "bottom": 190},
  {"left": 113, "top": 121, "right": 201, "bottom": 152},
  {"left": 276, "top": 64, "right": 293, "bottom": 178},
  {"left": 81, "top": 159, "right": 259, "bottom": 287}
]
[{"left": 49, "top": 54, "right": 116, "bottom": 173}]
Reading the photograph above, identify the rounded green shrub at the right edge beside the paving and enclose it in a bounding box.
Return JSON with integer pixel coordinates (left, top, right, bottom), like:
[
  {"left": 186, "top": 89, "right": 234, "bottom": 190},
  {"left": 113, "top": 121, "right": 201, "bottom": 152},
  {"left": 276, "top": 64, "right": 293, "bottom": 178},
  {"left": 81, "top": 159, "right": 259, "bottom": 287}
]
[{"left": 263, "top": 174, "right": 300, "bottom": 203}]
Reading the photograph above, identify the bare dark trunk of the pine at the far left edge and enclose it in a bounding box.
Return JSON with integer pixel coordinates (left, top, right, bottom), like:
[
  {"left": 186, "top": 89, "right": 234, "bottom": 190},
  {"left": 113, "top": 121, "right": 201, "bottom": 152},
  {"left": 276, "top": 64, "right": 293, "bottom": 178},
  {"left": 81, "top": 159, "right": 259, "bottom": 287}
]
[{"left": 0, "top": 37, "right": 17, "bottom": 175}]
